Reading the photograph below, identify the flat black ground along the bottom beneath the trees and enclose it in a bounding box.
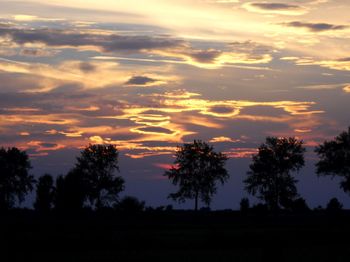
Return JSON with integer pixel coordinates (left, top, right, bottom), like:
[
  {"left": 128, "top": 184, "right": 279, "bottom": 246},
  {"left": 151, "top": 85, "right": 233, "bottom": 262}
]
[{"left": 0, "top": 210, "right": 350, "bottom": 262}]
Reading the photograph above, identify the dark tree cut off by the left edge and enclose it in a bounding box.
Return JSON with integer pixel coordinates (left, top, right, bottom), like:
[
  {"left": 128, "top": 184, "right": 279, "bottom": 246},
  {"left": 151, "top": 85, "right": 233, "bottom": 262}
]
[{"left": 0, "top": 147, "right": 35, "bottom": 209}]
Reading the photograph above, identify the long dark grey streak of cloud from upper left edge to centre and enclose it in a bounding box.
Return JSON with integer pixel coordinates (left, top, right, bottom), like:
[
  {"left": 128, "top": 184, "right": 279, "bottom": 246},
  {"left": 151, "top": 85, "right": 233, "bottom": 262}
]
[{"left": 0, "top": 27, "right": 185, "bottom": 52}]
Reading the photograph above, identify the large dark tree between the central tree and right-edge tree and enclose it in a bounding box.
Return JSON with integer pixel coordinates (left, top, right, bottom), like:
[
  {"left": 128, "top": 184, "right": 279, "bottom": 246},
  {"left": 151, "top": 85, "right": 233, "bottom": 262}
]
[{"left": 244, "top": 137, "right": 305, "bottom": 210}]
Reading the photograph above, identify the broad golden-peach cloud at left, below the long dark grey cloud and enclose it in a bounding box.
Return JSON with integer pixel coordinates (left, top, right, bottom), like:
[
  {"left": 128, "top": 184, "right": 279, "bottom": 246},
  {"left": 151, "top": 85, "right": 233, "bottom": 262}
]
[{"left": 0, "top": 58, "right": 180, "bottom": 92}]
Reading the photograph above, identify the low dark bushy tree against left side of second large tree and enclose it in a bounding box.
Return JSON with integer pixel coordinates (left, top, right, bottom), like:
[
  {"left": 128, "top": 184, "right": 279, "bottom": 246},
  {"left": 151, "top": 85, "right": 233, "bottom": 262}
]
[{"left": 54, "top": 169, "right": 87, "bottom": 212}]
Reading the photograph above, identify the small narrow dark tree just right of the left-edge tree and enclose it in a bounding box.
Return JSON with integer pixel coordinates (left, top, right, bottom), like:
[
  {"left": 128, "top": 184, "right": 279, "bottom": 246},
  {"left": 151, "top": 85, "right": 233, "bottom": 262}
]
[{"left": 34, "top": 174, "right": 55, "bottom": 212}]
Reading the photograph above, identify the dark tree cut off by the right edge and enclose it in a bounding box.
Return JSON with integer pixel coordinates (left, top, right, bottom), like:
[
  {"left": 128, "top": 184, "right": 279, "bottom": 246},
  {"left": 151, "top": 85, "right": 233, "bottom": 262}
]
[{"left": 315, "top": 127, "right": 350, "bottom": 193}]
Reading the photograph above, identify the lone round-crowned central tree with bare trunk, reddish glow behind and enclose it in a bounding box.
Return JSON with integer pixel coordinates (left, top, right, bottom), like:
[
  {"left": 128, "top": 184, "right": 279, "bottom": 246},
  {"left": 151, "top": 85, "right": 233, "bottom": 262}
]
[{"left": 164, "top": 140, "right": 229, "bottom": 210}]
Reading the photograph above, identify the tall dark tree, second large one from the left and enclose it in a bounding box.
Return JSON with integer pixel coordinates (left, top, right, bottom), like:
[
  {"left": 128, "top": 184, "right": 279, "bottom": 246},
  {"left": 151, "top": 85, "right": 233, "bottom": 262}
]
[{"left": 74, "top": 145, "right": 124, "bottom": 208}]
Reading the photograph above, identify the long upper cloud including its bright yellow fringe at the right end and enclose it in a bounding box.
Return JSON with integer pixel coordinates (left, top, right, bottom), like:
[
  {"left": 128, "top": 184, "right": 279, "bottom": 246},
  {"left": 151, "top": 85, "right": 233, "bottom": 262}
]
[{"left": 0, "top": 22, "right": 272, "bottom": 69}]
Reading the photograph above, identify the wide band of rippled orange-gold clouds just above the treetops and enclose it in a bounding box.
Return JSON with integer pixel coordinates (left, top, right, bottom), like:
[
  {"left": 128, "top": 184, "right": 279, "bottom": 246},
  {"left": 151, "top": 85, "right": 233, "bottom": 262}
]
[{"left": 0, "top": 88, "right": 321, "bottom": 158}]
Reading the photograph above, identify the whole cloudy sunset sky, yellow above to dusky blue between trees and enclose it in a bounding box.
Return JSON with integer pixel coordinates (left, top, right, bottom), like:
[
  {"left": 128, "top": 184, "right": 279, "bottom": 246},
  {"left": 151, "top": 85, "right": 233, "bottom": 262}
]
[{"left": 0, "top": 0, "right": 350, "bottom": 209}]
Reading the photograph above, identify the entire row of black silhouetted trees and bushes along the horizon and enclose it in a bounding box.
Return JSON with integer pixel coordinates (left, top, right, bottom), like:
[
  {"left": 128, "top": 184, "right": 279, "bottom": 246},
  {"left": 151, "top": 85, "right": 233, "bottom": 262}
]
[{"left": 0, "top": 127, "right": 350, "bottom": 213}]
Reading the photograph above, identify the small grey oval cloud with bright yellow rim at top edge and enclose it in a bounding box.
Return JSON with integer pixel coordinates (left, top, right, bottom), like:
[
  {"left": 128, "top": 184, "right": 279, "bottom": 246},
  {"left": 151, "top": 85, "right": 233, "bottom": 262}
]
[{"left": 243, "top": 2, "right": 307, "bottom": 15}]
